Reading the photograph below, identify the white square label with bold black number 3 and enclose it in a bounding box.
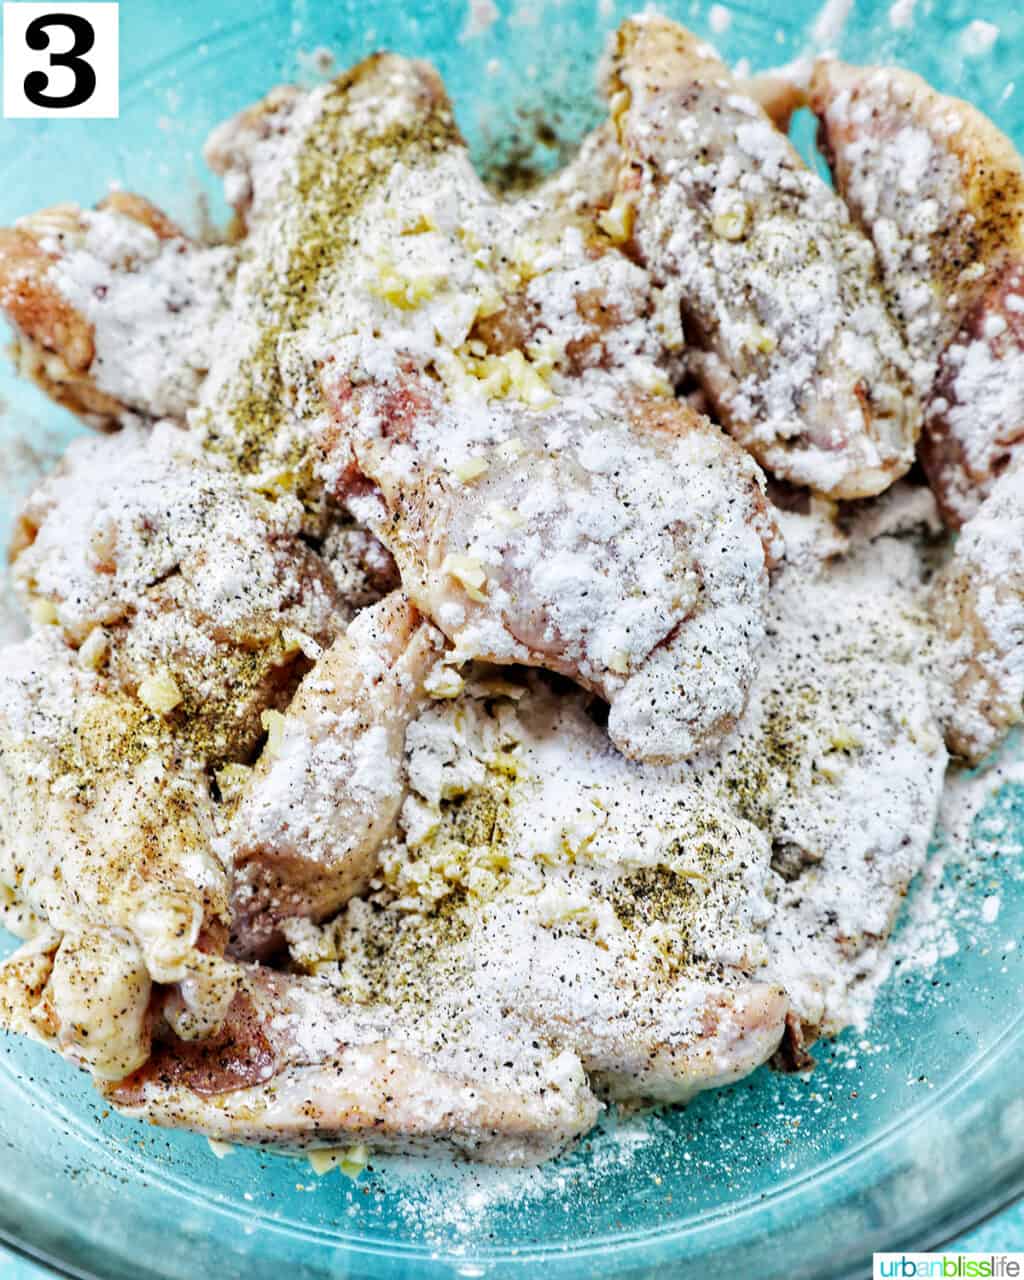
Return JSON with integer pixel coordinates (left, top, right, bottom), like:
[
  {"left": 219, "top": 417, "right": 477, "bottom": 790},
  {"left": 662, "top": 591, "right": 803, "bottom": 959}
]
[{"left": 4, "top": 0, "right": 118, "bottom": 120}]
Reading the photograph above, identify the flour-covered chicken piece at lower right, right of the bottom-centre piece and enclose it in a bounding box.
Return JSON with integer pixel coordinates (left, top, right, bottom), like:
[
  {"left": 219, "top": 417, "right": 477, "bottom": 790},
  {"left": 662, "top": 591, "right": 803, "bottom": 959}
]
[{"left": 721, "top": 529, "right": 946, "bottom": 1039}]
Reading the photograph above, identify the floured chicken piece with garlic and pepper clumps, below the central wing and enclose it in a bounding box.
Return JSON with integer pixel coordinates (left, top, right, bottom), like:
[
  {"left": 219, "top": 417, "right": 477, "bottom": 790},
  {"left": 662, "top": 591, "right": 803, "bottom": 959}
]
[{"left": 316, "top": 668, "right": 788, "bottom": 1102}]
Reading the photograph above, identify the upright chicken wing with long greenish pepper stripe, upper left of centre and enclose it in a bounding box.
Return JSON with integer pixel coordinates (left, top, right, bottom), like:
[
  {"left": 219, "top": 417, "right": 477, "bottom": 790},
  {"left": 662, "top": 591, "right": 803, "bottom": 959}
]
[{"left": 192, "top": 54, "right": 463, "bottom": 504}]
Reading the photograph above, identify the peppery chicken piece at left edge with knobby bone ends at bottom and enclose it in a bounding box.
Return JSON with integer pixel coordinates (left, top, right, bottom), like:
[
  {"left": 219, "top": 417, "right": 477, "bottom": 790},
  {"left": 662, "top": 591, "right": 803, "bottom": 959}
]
[{"left": 0, "top": 628, "right": 230, "bottom": 1076}]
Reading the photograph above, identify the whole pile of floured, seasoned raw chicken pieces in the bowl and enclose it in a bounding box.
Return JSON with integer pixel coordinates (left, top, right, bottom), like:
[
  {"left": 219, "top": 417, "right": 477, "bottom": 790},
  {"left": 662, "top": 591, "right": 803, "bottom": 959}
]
[{"left": 0, "top": 32, "right": 983, "bottom": 1165}]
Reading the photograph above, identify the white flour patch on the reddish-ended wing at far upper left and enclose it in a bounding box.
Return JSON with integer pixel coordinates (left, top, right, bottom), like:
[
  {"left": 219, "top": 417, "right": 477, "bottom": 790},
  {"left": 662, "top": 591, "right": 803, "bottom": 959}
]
[{"left": 52, "top": 210, "right": 236, "bottom": 419}]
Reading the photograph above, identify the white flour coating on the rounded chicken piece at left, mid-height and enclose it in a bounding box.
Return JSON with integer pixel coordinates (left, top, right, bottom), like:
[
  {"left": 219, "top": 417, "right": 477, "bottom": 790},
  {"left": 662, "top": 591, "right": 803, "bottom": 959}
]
[{"left": 14, "top": 428, "right": 332, "bottom": 641}]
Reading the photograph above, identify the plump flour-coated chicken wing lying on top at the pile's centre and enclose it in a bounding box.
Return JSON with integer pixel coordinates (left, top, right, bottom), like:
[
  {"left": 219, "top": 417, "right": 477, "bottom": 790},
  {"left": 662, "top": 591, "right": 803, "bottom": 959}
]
[{"left": 325, "top": 372, "right": 777, "bottom": 760}]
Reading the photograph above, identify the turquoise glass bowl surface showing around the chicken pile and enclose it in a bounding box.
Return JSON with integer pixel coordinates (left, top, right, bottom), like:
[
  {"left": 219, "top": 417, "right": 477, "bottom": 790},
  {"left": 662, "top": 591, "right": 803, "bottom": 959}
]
[{"left": 0, "top": 0, "right": 1024, "bottom": 1280}]
